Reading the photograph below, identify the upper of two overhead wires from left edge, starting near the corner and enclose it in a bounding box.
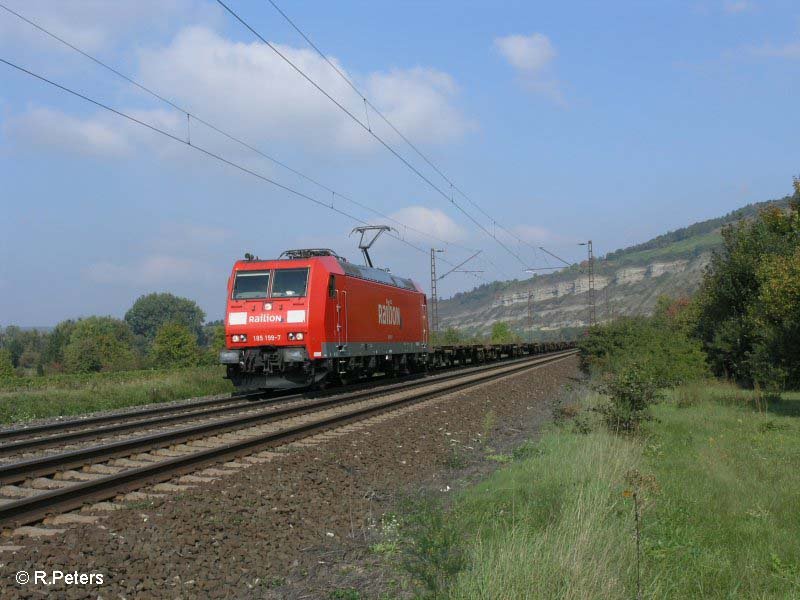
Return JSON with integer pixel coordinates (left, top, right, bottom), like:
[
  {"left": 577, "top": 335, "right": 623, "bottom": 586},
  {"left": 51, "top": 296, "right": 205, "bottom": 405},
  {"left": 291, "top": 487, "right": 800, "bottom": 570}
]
[{"left": 0, "top": 2, "right": 488, "bottom": 264}]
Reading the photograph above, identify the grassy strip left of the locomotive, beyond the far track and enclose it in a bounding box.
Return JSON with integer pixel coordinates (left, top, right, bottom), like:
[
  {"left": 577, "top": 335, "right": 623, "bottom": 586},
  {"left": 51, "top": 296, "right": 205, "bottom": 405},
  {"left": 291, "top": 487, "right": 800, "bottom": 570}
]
[{"left": 0, "top": 366, "right": 233, "bottom": 423}]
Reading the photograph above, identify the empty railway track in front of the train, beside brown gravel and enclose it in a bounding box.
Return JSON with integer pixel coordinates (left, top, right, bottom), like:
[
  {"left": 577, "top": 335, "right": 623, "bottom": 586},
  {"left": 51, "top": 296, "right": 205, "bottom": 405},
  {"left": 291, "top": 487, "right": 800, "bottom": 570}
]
[{"left": 0, "top": 350, "right": 575, "bottom": 528}]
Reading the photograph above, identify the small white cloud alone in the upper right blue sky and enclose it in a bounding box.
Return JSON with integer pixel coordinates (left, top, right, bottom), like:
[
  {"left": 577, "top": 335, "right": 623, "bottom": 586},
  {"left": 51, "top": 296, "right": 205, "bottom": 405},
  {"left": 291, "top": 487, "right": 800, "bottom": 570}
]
[{"left": 494, "top": 33, "right": 565, "bottom": 104}]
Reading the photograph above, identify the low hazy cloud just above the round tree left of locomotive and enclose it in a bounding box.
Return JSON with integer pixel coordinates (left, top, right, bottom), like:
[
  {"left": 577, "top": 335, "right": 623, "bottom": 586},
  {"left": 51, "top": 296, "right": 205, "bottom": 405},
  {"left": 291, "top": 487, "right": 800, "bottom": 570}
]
[{"left": 84, "top": 255, "right": 210, "bottom": 287}]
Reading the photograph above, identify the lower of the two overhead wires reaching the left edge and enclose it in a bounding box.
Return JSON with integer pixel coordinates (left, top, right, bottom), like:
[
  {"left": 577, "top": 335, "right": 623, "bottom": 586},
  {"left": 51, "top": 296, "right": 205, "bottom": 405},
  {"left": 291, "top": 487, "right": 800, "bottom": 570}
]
[{"left": 0, "top": 57, "right": 494, "bottom": 282}]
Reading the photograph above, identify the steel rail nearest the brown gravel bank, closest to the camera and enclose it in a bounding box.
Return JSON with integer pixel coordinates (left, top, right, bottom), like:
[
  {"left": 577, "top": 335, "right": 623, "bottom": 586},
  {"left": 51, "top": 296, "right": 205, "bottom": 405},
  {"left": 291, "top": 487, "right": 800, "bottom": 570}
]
[{"left": 0, "top": 350, "right": 576, "bottom": 527}]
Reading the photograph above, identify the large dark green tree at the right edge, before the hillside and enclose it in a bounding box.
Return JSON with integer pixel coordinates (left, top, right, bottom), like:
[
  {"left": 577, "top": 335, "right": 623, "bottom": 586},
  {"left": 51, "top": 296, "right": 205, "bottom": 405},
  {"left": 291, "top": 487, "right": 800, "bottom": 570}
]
[{"left": 696, "top": 179, "right": 800, "bottom": 385}]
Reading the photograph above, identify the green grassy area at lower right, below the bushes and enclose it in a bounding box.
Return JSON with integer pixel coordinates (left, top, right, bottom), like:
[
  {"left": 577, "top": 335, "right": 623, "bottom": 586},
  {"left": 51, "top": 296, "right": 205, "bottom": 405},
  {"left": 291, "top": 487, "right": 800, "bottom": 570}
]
[{"left": 400, "top": 384, "right": 800, "bottom": 600}]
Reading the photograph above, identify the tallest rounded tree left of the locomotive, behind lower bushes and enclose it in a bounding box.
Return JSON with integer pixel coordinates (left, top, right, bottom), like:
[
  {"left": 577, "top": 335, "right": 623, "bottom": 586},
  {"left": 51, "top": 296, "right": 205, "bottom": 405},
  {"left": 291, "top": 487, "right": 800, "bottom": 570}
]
[{"left": 125, "top": 293, "right": 206, "bottom": 343}]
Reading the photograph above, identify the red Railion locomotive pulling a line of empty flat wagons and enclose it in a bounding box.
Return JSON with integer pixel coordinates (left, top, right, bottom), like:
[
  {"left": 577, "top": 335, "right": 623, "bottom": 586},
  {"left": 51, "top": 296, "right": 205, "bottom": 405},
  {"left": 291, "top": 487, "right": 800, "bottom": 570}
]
[{"left": 219, "top": 248, "right": 570, "bottom": 392}]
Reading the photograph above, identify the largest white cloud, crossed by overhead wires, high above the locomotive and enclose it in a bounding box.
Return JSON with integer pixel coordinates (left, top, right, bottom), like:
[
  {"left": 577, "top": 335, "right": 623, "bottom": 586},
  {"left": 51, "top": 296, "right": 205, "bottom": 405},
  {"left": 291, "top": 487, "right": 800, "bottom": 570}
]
[{"left": 140, "top": 27, "right": 473, "bottom": 150}]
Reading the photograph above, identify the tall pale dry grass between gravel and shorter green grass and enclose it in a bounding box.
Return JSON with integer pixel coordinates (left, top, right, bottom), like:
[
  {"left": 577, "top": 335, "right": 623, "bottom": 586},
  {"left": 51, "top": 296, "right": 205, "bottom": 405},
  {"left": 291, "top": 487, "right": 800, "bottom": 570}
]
[{"left": 450, "top": 433, "right": 641, "bottom": 600}]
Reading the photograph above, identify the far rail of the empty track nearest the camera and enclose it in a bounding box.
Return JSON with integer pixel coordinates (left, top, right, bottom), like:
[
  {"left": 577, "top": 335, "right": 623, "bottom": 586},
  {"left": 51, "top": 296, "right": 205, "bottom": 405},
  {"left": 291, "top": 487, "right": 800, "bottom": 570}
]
[{"left": 0, "top": 351, "right": 572, "bottom": 484}]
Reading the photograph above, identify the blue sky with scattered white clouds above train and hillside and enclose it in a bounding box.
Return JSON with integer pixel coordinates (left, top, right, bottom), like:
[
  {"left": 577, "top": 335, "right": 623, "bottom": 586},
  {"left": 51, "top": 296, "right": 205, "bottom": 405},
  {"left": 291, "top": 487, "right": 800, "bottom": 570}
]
[{"left": 0, "top": 0, "right": 800, "bottom": 326}]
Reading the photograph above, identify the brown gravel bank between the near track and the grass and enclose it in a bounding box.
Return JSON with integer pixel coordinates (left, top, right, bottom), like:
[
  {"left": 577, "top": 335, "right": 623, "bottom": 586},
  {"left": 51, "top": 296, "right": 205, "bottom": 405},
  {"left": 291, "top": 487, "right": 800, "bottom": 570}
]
[{"left": 0, "top": 358, "right": 577, "bottom": 598}]
